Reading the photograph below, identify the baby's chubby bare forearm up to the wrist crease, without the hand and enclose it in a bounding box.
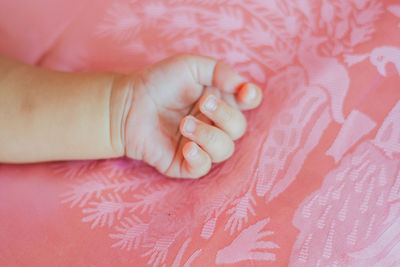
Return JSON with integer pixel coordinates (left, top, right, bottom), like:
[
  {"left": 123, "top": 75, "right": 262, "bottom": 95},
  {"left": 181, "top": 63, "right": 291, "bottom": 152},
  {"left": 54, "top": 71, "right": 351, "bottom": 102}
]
[{"left": 0, "top": 57, "right": 132, "bottom": 163}]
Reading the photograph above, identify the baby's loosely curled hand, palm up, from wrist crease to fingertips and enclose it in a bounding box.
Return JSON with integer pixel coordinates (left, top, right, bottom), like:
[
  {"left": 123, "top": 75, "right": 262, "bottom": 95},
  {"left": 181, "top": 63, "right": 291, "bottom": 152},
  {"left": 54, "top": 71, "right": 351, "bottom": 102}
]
[{"left": 125, "top": 55, "right": 262, "bottom": 178}]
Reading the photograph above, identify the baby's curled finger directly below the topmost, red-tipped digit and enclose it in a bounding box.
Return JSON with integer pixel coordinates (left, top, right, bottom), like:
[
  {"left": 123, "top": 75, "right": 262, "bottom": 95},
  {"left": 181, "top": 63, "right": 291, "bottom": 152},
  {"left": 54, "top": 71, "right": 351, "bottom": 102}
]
[{"left": 199, "top": 94, "right": 247, "bottom": 140}]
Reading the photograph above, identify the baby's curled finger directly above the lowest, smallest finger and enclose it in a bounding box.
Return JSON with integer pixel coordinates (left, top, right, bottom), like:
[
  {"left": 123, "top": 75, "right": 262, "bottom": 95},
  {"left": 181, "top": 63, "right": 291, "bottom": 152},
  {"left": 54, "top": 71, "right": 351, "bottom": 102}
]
[{"left": 180, "top": 116, "right": 235, "bottom": 162}]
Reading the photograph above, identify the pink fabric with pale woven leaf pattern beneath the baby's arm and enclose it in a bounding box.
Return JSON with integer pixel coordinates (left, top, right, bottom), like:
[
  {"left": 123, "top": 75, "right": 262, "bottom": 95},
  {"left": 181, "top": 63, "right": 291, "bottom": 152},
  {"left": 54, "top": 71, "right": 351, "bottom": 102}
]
[{"left": 0, "top": 0, "right": 400, "bottom": 267}]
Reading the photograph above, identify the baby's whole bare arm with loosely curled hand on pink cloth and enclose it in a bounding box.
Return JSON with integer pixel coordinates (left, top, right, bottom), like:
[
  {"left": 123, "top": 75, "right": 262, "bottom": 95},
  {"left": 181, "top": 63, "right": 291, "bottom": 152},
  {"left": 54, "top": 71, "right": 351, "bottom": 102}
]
[{"left": 0, "top": 54, "right": 262, "bottom": 178}]
